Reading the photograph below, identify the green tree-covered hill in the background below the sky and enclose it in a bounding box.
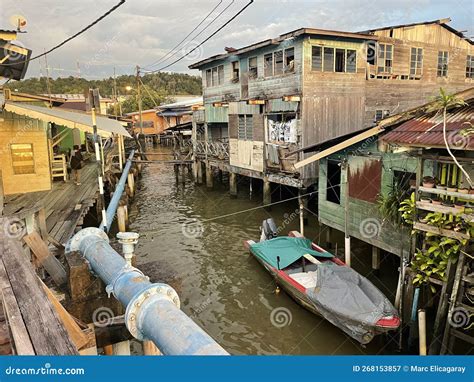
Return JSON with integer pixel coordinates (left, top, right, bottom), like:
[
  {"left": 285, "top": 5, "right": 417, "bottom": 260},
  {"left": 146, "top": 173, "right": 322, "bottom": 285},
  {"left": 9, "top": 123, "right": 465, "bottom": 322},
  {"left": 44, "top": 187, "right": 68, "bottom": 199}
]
[{"left": 5, "top": 73, "right": 202, "bottom": 102}]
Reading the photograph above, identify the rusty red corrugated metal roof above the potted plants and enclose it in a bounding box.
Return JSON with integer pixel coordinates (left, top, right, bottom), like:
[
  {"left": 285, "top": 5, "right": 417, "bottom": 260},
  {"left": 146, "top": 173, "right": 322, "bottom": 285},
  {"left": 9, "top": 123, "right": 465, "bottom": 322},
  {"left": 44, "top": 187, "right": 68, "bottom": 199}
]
[{"left": 381, "top": 99, "right": 474, "bottom": 150}]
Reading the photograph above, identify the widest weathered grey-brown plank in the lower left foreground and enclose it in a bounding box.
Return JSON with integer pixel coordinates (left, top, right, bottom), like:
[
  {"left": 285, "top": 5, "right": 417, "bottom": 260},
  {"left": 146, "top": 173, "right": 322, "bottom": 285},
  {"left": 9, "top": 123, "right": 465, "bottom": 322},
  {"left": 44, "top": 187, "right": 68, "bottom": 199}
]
[{"left": 1, "top": 240, "right": 78, "bottom": 355}]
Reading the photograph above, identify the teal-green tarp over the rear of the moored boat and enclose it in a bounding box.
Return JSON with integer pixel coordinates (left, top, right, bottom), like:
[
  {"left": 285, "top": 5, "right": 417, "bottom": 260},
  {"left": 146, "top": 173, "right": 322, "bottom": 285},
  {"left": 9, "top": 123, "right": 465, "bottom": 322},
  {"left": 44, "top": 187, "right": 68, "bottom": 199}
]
[{"left": 250, "top": 237, "right": 334, "bottom": 269}]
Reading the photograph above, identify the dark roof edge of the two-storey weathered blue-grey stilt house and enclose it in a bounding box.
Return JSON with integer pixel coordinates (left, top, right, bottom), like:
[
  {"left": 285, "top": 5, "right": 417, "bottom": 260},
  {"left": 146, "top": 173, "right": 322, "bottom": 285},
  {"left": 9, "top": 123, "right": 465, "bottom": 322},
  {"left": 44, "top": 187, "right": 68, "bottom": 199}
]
[{"left": 189, "top": 28, "right": 378, "bottom": 69}]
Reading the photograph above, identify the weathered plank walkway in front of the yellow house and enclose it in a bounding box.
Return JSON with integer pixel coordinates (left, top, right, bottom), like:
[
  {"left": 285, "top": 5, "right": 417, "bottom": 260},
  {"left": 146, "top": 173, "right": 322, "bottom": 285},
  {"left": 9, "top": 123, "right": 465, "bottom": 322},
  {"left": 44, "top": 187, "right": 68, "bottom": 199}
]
[{"left": 4, "top": 163, "right": 98, "bottom": 244}]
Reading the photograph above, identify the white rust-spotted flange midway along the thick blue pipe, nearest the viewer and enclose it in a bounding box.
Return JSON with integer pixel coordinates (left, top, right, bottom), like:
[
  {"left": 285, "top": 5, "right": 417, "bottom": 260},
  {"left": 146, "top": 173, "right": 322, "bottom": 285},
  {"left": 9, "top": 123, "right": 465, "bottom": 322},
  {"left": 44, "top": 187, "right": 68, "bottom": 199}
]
[{"left": 125, "top": 283, "right": 180, "bottom": 341}]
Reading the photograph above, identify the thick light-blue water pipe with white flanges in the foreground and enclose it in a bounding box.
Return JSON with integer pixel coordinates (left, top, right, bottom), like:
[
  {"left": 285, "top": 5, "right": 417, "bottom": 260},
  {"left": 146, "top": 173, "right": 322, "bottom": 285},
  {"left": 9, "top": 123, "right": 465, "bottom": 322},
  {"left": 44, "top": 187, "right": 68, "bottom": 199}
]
[{"left": 66, "top": 228, "right": 228, "bottom": 355}]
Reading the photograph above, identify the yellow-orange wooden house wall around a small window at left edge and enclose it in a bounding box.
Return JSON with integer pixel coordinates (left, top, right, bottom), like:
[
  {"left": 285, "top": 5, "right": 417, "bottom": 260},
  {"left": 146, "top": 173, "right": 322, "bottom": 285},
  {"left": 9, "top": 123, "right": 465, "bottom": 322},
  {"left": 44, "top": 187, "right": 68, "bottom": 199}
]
[{"left": 0, "top": 109, "right": 51, "bottom": 195}]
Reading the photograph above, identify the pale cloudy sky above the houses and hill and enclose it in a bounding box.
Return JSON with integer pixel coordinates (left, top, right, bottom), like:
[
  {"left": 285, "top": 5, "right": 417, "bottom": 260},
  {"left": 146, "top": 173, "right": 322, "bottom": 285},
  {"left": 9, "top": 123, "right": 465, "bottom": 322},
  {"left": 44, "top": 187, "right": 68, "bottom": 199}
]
[{"left": 0, "top": 0, "right": 474, "bottom": 79}]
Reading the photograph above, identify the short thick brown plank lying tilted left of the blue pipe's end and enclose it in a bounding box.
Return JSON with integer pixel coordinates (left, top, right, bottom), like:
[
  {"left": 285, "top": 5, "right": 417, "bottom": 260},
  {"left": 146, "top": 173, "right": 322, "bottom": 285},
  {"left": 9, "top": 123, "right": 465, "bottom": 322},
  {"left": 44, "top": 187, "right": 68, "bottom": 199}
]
[{"left": 23, "top": 232, "right": 67, "bottom": 286}]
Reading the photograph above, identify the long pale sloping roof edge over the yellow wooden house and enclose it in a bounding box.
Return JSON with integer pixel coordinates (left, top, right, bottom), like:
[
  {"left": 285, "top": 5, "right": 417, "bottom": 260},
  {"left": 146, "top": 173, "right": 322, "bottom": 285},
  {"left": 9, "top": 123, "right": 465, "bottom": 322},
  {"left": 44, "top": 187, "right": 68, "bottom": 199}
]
[{"left": 4, "top": 102, "right": 131, "bottom": 138}]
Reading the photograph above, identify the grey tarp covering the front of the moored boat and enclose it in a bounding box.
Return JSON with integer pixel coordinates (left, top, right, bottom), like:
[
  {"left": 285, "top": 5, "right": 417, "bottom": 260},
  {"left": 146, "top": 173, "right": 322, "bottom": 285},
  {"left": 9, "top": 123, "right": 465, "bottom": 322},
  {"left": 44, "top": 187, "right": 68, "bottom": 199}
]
[{"left": 306, "top": 261, "right": 398, "bottom": 344}]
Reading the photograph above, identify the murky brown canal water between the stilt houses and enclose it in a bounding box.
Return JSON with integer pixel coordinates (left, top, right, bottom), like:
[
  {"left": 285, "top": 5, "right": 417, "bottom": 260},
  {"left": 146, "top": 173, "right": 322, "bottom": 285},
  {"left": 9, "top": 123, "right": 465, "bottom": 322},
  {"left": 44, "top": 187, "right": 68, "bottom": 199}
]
[{"left": 131, "top": 149, "right": 397, "bottom": 354}]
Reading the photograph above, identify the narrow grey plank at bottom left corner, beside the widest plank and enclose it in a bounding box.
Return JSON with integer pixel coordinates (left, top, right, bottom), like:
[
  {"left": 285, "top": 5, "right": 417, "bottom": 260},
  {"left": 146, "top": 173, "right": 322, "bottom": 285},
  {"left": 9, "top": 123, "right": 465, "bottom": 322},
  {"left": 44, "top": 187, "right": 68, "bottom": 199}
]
[{"left": 0, "top": 261, "right": 35, "bottom": 355}]
